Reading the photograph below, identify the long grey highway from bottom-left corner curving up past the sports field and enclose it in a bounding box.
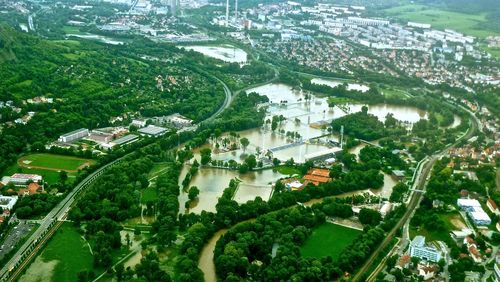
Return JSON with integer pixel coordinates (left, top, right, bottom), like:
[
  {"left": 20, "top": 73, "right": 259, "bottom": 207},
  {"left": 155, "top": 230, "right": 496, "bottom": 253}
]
[{"left": 0, "top": 72, "right": 232, "bottom": 282}]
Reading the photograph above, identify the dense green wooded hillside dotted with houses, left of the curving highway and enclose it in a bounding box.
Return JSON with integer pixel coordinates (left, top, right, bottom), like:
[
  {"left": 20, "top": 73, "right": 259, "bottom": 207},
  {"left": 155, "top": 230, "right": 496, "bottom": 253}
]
[{"left": 0, "top": 25, "right": 224, "bottom": 174}]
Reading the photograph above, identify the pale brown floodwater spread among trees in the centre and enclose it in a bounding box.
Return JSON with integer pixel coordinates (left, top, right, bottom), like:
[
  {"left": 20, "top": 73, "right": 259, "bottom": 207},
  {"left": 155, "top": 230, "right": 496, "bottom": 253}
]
[{"left": 179, "top": 83, "right": 427, "bottom": 213}]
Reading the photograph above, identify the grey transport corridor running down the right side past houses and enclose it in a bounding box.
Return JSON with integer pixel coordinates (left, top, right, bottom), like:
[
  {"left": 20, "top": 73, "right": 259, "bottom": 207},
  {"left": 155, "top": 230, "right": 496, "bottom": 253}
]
[{"left": 352, "top": 107, "right": 480, "bottom": 281}]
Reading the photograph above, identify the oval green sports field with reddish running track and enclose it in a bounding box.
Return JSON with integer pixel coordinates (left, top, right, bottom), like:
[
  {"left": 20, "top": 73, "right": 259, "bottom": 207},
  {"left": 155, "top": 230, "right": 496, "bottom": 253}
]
[{"left": 17, "top": 154, "right": 95, "bottom": 172}]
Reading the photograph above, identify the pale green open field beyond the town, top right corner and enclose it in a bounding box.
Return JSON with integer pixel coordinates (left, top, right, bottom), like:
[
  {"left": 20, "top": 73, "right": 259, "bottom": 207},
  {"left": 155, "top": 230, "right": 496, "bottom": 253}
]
[{"left": 384, "top": 4, "right": 499, "bottom": 38}]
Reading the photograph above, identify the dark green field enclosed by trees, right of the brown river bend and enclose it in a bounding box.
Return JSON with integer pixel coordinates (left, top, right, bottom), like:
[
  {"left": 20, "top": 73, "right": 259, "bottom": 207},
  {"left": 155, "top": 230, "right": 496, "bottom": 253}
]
[{"left": 300, "top": 223, "right": 361, "bottom": 260}]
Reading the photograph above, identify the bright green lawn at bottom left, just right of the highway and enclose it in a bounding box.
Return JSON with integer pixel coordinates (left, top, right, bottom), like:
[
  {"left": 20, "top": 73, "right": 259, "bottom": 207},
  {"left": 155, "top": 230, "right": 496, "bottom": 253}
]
[{"left": 42, "top": 222, "right": 96, "bottom": 282}]
